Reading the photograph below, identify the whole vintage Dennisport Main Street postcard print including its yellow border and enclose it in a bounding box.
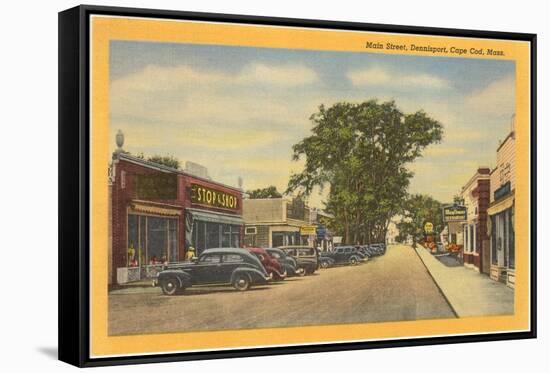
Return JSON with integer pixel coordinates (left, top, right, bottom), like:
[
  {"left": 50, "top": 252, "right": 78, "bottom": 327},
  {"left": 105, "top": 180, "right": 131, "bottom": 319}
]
[{"left": 85, "top": 16, "right": 530, "bottom": 356}]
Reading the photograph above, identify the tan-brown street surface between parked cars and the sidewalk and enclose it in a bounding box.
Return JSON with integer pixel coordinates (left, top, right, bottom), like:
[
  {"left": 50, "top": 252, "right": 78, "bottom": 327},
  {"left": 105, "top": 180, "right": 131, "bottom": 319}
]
[{"left": 109, "top": 246, "right": 454, "bottom": 335}]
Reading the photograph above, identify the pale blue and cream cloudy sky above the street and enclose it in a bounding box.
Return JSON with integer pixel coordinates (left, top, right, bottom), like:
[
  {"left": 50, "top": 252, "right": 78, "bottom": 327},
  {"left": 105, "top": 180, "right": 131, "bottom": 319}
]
[{"left": 110, "top": 41, "right": 515, "bottom": 205}]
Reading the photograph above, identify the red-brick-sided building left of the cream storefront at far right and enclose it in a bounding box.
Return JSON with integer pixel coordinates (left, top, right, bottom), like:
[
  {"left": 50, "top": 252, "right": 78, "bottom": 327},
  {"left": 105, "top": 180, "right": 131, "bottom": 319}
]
[{"left": 457, "top": 167, "right": 491, "bottom": 274}]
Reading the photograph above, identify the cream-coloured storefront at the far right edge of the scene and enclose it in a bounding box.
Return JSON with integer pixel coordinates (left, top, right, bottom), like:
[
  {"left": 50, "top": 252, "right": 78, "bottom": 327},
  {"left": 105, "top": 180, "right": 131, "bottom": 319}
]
[{"left": 487, "top": 127, "right": 516, "bottom": 288}]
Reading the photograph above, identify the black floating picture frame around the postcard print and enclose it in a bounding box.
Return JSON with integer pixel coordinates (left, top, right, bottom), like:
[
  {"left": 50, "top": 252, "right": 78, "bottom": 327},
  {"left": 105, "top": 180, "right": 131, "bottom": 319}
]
[{"left": 58, "top": 5, "right": 537, "bottom": 367}]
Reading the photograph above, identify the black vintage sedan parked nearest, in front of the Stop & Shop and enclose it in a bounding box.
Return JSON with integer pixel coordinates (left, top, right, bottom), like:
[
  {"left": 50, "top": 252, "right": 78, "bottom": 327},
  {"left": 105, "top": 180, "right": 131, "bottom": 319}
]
[{"left": 157, "top": 248, "right": 271, "bottom": 295}]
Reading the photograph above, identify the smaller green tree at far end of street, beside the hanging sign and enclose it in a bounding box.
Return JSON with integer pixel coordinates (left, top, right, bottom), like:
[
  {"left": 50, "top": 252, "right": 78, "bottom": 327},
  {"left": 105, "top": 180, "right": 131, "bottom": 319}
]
[{"left": 397, "top": 194, "right": 444, "bottom": 247}]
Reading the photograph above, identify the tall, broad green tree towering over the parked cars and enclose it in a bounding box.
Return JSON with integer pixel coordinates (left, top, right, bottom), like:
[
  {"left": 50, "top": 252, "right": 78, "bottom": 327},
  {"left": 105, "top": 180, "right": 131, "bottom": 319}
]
[{"left": 286, "top": 100, "right": 443, "bottom": 243}]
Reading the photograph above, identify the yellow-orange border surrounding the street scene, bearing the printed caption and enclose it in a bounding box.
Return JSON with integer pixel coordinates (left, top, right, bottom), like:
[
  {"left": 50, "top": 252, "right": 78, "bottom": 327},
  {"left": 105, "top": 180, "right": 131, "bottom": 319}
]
[{"left": 90, "top": 16, "right": 530, "bottom": 358}]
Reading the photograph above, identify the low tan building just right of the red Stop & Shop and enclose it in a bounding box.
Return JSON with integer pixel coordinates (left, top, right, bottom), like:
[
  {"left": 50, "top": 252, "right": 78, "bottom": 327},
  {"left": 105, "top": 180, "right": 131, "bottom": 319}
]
[{"left": 243, "top": 198, "right": 317, "bottom": 247}]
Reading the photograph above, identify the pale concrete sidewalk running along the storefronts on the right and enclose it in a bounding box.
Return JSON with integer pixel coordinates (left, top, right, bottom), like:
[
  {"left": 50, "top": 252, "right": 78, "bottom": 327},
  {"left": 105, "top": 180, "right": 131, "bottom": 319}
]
[{"left": 415, "top": 246, "right": 514, "bottom": 317}]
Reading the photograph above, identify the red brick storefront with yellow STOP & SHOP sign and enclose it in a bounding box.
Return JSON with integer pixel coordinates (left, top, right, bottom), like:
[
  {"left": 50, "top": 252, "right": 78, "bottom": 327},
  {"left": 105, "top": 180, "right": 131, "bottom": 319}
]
[{"left": 110, "top": 150, "right": 244, "bottom": 283}]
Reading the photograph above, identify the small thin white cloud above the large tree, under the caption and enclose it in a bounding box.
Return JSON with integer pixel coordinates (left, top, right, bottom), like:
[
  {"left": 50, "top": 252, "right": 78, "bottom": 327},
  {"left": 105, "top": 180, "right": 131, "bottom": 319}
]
[{"left": 347, "top": 67, "right": 450, "bottom": 89}]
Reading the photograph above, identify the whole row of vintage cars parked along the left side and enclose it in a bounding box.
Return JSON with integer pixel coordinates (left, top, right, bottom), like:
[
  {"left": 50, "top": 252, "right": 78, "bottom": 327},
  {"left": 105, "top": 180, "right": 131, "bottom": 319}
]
[{"left": 155, "top": 244, "right": 386, "bottom": 295}]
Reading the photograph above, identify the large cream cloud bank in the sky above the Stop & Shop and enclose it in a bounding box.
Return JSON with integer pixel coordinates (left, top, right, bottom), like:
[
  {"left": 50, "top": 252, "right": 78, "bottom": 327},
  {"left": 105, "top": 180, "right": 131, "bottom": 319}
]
[{"left": 110, "top": 63, "right": 318, "bottom": 127}]
